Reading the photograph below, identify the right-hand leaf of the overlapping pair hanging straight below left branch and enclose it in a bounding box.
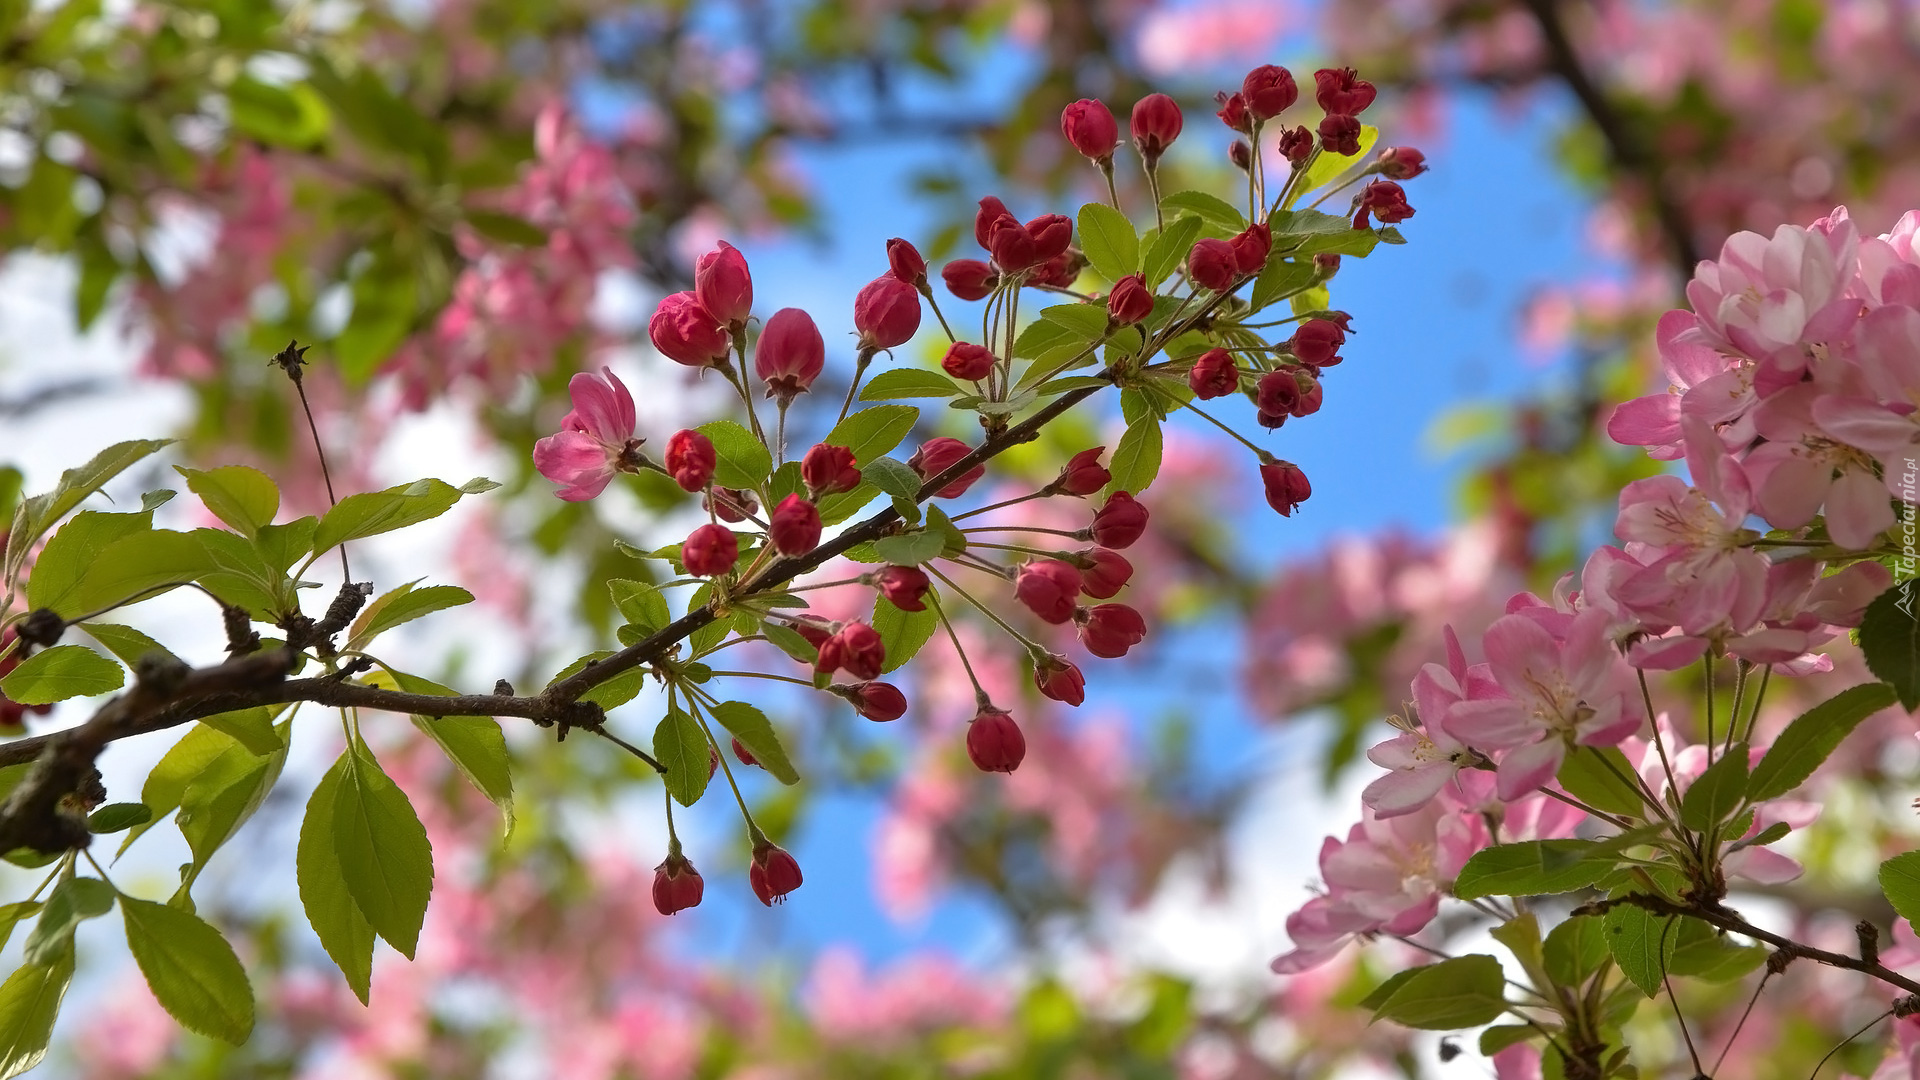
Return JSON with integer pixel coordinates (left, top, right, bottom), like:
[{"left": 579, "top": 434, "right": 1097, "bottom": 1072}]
[{"left": 334, "top": 740, "right": 434, "bottom": 961}]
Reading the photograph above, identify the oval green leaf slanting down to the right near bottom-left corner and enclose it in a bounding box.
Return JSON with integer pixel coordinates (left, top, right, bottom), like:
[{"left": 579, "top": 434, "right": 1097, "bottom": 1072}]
[{"left": 121, "top": 896, "right": 253, "bottom": 1045}]
